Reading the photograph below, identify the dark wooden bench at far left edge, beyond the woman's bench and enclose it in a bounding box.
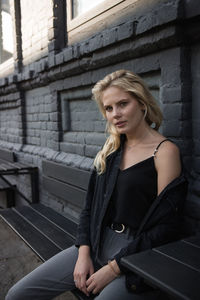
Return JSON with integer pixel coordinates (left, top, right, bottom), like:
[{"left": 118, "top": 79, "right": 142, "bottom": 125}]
[{"left": 0, "top": 149, "right": 39, "bottom": 207}]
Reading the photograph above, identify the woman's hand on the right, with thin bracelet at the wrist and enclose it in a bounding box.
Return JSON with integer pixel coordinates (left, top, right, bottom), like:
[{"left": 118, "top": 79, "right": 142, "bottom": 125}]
[{"left": 86, "top": 261, "right": 120, "bottom": 294}]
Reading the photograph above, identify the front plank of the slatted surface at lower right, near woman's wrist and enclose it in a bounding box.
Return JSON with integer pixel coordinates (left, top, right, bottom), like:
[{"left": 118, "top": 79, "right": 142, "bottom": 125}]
[{"left": 122, "top": 250, "right": 200, "bottom": 300}]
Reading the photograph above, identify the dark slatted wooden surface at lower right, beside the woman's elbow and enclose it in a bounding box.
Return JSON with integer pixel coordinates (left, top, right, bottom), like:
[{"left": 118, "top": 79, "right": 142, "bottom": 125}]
[{"left": 122, "top": 233, "right": 200, "bottom": 300}]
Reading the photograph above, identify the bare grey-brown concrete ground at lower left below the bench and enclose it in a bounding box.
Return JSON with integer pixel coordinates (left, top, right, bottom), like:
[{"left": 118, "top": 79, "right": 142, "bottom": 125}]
[{"left": 0, "top": 217, "right": 76, "bottom": 300}]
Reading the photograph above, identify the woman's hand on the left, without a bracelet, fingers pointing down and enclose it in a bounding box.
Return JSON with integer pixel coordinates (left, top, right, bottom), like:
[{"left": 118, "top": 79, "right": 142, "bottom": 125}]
[{"left": 74, "top": 246, "right": 94, "bottom": 296}]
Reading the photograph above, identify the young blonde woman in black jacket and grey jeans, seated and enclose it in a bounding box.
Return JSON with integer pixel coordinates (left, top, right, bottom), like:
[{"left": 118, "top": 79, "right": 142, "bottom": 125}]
[{"left": 6, "top": 70, "right": 186, "bottom": 300}]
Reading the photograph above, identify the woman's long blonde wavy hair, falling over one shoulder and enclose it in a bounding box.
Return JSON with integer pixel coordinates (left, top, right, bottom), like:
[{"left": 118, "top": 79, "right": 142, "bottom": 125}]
[{"left": 92, "top": 70, "right": 162, "bottom": 174}]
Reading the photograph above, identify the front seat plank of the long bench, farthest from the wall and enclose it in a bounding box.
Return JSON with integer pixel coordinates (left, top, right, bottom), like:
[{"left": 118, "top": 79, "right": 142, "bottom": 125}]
[{"left": 0, "top": 209, "right": 61, "bottom": 261}]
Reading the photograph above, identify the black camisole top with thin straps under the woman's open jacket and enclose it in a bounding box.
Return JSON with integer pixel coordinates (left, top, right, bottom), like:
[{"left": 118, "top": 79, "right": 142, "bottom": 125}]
[{"left": 107, "top": 140, "right": 169, "bottom": 229}]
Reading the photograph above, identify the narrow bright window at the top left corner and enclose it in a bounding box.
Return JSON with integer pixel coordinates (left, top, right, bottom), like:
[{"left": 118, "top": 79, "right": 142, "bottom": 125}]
[{"left": 0, "top": 0, "right": 13, "bottom": 63}]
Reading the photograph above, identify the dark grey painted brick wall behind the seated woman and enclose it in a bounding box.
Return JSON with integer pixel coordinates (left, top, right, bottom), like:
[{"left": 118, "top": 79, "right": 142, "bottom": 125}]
[{"left": 0, "top": 0, "right": 200, "bottom": 220}]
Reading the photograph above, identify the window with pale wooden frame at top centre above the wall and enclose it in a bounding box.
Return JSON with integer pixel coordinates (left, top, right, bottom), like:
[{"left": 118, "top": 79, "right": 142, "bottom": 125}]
[{"left": 67, "top": 0, "right": 134, "bottom": 43}]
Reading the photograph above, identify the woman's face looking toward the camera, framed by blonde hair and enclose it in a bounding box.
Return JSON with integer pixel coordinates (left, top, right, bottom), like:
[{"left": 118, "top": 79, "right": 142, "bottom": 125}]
[{"left": 102, "top": 86, "right": 145, "bottom": 135}]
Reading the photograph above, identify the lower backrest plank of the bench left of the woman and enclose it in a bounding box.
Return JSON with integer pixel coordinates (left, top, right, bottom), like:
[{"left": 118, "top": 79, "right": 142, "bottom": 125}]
[{"left": 42, "top": 176, "right": 86, "bottom": 208}]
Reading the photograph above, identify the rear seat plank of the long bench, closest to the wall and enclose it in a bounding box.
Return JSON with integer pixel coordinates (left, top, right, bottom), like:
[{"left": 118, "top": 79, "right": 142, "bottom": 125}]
[{"left": 31, "top": 203, "right": 77, "bottom": 237}]
